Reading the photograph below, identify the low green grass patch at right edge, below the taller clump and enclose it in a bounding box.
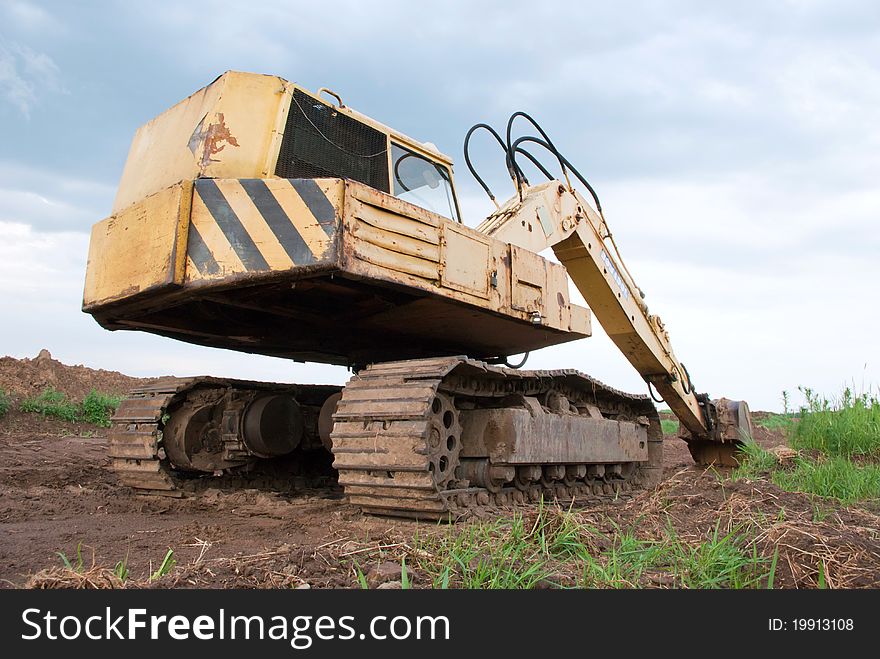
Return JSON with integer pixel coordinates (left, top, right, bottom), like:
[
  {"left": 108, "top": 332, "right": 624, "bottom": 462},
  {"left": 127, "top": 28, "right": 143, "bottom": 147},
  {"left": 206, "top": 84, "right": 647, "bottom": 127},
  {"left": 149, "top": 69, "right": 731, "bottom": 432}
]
[{"left": 772, "top": 456, "right": 880, "bottom": 504}]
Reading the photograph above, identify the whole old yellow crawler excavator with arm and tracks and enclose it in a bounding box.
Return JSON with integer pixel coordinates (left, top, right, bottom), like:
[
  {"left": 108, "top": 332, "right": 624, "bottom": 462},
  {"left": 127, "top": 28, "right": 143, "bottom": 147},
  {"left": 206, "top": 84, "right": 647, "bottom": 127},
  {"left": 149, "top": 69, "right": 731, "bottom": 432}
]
[{"left": 83, "top": 71, "right": 751, "bottom": 519}]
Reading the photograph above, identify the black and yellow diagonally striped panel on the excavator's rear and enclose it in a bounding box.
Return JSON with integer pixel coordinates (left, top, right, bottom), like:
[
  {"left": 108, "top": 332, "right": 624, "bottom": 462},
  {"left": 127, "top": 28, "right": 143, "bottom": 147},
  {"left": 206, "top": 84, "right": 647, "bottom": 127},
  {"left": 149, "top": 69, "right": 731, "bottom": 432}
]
[{"left": 186, "top": 179, "right": 343, "bottom": 281}]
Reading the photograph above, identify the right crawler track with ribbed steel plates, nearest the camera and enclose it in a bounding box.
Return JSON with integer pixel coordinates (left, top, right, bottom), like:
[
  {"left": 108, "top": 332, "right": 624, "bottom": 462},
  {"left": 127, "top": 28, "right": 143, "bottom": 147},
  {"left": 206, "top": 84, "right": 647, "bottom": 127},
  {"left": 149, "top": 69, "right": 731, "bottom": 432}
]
[{"left": 331, "top": 357, "right": 663, "bottom": 520}]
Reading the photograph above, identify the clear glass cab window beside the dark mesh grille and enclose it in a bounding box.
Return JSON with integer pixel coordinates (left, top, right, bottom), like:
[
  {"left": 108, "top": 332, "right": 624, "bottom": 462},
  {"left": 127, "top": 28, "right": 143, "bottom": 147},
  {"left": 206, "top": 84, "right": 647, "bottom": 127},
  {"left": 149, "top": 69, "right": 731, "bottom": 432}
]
[{"left": 391, "top": 142, "right": 458, "bottom": 220}]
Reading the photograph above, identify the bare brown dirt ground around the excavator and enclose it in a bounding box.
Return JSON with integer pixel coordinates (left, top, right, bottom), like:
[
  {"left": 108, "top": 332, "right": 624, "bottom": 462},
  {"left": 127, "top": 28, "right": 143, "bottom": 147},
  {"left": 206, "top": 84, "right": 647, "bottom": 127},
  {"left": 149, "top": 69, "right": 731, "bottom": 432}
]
[{"left": 0, "top": 355, "right": 880, "bottom": 588}]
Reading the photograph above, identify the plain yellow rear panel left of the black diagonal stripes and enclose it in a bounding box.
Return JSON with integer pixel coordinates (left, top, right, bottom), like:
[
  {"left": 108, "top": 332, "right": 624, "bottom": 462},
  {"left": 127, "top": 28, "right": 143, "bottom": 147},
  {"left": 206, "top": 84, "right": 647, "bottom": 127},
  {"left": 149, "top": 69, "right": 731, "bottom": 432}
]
[{"left": 83, "top": 182, "right": 192, "bottom": 311}]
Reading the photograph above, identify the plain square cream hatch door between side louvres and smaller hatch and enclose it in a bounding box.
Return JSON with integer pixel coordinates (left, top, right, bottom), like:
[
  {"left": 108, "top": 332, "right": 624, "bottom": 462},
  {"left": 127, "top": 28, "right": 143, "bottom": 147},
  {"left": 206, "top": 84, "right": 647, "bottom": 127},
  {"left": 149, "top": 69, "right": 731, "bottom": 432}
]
[{"left": 440, "top": 222, "right": 491, "bottom": 298}]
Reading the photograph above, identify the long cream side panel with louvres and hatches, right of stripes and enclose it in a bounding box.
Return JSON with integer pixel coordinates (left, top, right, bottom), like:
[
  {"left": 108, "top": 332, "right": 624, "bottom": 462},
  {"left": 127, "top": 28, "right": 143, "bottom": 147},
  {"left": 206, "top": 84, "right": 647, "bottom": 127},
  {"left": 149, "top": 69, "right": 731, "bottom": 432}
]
[{"left": 341, "top": 181, "right": 590, "bottom": 336}]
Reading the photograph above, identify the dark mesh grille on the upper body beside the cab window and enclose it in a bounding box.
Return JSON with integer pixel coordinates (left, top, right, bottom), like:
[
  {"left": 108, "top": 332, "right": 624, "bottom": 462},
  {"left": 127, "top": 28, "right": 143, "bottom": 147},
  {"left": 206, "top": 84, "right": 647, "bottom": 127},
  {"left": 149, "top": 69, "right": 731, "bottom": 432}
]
[{"left": 275, "top": 89, "right": 389, "bottom": 192}]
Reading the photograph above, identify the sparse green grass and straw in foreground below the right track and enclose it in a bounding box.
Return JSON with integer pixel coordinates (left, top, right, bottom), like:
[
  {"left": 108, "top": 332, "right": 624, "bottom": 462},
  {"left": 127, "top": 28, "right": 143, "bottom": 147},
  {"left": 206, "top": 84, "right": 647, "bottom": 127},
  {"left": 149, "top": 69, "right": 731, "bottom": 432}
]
[{"left": 408, "top": 506, "right": 770, "bottom": 588}]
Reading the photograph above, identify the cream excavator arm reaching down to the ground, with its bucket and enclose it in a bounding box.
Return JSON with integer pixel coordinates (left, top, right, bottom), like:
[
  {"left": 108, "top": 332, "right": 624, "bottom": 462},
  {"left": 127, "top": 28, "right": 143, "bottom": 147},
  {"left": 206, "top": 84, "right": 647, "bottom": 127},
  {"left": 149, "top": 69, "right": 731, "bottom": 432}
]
[{"left": 478, "top": 180, "right": 752, "bottom": 464}]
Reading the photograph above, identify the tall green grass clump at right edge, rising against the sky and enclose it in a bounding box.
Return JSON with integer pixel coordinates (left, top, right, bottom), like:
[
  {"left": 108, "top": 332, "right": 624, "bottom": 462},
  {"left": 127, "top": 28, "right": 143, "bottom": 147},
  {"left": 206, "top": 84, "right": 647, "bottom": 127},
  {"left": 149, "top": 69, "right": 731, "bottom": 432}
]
[{"left": 791, "top": 387, "right": 880, "bottom": 458}]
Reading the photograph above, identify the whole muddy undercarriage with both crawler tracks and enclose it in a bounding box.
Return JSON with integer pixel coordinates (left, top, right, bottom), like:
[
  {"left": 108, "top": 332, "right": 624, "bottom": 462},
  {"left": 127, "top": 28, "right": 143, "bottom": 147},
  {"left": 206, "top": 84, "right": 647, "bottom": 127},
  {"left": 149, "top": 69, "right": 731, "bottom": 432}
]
[{"left": 110, "top": 357, "right": 663, "bottom": 519}]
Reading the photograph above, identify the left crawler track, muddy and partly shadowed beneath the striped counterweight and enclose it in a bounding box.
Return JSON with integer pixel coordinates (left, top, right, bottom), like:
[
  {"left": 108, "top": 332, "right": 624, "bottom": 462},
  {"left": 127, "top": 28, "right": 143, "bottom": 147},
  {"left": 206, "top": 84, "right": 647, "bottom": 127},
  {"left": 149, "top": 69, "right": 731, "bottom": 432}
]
[{"left": 108, "top": 377, "right": 340, "bottom": 497}]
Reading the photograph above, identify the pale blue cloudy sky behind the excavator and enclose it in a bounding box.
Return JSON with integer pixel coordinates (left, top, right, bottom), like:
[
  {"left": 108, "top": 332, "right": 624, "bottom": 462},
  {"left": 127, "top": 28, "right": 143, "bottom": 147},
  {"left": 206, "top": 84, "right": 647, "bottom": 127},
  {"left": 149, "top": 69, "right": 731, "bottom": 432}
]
[{"left": 0, "top": 0, "right": 880, "bottom": 409}]
